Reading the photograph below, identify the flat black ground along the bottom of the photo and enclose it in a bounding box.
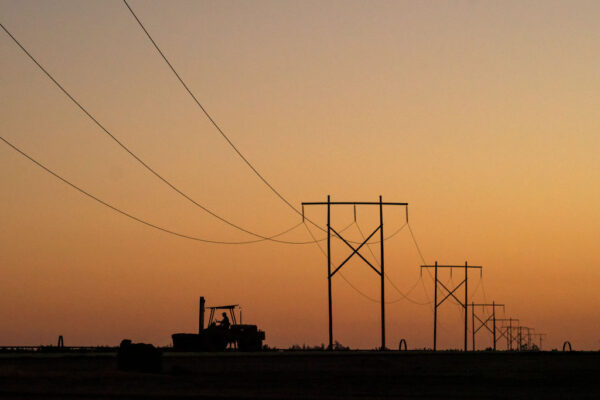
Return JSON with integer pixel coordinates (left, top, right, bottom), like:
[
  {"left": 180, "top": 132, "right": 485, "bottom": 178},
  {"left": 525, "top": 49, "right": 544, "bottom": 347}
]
[{"left": 0, "top": 351, "right": 600, "bottom": 399}]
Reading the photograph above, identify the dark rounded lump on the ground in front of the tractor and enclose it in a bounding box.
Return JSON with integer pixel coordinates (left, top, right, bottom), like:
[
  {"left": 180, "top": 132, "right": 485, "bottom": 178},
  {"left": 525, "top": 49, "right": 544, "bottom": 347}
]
[{"left": 117, "top": 339, "right": 162, "bottom": 372}]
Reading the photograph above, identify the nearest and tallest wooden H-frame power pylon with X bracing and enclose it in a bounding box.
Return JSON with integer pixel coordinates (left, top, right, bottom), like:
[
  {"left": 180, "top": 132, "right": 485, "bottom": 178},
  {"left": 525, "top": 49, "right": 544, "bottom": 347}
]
[{"left": 302, "top": 196, "right": 408, "bottom": 350}]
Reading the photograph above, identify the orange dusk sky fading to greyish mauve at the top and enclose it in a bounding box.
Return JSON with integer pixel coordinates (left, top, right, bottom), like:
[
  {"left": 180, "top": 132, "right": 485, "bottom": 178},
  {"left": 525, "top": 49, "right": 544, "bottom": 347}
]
[{"left": 0, "top": 0, "right": 600, "bottom": 349}]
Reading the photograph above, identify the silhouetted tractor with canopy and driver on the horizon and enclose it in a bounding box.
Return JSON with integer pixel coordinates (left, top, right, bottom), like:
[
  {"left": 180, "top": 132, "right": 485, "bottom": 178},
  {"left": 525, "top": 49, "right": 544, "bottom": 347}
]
[{"left": 172, "top": 297, "right": 265, "bottom": 352}]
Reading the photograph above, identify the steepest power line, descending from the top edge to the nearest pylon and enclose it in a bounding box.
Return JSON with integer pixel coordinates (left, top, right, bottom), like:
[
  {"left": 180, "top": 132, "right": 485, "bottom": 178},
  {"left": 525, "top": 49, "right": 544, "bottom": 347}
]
[{"left": 123, "top": 0, "right": 325, "bottom": 232}]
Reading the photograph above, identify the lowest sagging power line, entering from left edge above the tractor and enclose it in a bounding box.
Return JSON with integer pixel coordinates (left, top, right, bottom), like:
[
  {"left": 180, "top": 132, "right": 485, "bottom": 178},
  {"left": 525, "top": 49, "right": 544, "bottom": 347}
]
[{"left": 0, "top": 136, "right": 313, "bottom": 244}]
